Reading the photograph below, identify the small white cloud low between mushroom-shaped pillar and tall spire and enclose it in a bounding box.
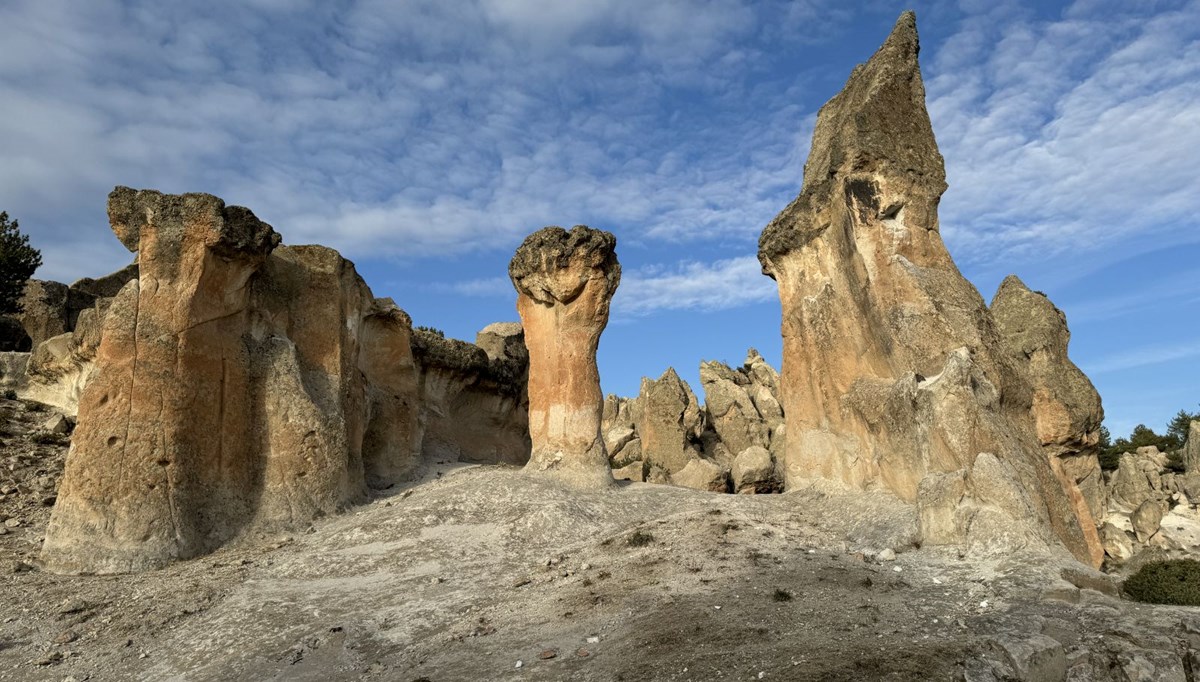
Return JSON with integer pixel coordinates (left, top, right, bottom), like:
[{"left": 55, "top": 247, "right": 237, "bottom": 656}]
[{"left": 612, "top": 256, "right": 779, "bottom": 317}]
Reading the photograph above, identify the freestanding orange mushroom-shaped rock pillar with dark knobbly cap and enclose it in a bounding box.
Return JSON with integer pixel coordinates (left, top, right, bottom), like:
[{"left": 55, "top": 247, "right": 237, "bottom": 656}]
[{"left": 509, "top": 225, "right": 620, "bottom": 487}]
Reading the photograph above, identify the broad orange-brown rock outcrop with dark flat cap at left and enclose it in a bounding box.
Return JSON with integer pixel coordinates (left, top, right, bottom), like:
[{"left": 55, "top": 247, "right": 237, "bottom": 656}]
[{"left": 42, "top": 187, "right": 427, "bottom": 573}]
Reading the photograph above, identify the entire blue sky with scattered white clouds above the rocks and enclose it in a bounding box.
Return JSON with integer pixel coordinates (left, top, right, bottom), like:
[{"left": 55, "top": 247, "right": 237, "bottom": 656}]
[{"left": 0, "top": 0, "right": 1200, "bottom": 435}]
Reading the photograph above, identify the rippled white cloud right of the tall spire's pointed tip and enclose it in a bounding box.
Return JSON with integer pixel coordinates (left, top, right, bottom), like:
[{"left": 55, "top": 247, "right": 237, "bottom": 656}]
[{"left": 928, "top": 1, "right": 1200, "bottom": 271}]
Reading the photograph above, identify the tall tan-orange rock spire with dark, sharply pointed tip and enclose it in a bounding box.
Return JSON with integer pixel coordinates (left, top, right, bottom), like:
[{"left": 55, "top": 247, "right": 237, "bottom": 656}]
[{"left": 758, "top": 13, "right": 1103, "bottom": 564}]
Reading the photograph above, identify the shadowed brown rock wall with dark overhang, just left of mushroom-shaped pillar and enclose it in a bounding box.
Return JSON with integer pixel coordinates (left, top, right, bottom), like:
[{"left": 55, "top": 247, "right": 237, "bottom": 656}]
[{"left": 413, "top": 323, "right": 530, "bottom": 465}]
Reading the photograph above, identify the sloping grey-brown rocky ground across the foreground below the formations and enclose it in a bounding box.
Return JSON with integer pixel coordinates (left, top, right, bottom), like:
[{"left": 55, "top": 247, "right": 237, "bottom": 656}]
[{"left": 0, "top": 401, "right": 1200, "bottom": 681}]
